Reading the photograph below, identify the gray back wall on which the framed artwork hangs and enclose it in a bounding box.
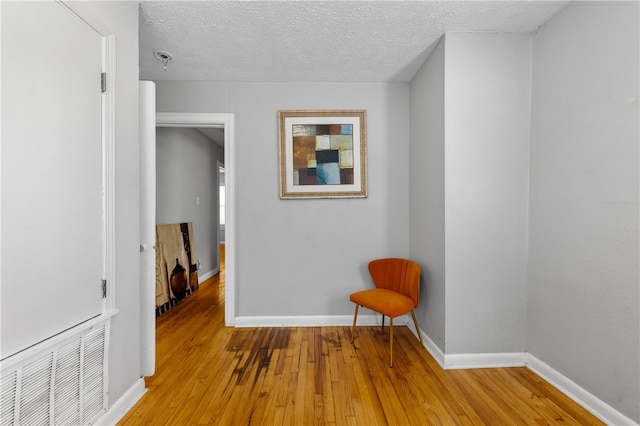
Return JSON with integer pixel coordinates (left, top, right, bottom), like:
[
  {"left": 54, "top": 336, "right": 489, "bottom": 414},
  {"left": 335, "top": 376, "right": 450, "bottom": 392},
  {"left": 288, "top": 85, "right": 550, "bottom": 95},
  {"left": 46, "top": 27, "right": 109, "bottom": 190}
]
[{"left": 157, "top": 81, "right": 409, "bottom": 316}]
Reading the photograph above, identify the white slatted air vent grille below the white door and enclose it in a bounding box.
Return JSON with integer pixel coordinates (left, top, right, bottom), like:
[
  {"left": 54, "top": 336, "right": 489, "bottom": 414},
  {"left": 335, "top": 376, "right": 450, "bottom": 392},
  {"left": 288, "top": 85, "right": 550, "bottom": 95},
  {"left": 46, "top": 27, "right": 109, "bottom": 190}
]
[{"left": 0, "top": 322, "right": 108, "bottom": 426}]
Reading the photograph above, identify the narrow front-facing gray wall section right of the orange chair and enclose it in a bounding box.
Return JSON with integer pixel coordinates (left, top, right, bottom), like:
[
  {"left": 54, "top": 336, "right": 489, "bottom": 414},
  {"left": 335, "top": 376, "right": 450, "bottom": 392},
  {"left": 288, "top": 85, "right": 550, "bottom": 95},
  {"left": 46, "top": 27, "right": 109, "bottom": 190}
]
[{"left": 444, "top": 34, "right": 531, "bottom": 354}]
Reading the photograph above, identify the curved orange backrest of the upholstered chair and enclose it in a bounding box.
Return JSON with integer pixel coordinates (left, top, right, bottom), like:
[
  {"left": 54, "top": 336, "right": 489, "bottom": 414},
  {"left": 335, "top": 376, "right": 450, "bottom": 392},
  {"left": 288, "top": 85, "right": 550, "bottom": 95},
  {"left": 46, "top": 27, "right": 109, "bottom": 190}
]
[{"left": 369, "top": 258, "right": 420, "bottom": 308}]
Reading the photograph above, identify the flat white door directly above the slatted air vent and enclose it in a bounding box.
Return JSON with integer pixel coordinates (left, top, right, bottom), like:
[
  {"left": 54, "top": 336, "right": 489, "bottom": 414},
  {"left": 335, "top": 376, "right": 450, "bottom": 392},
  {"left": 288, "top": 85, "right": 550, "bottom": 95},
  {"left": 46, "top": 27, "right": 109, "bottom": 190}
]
[{"left": 0, "top": 1, "right": 105, "bottom": 358}]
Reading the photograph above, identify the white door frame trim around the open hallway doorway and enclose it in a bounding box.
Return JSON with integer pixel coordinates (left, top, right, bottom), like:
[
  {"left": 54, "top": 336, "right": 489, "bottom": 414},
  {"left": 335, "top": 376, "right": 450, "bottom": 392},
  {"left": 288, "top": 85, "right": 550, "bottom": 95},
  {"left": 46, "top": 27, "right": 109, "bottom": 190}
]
[{"left": 156, "top": 112, "right": 236, "bottom": 327}]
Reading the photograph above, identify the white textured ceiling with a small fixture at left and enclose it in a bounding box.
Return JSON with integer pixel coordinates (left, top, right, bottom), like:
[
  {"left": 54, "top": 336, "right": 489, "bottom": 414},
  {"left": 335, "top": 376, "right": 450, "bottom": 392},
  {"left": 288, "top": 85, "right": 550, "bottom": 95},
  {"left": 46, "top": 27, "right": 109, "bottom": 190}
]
[{"left": 140, "top": 0, "right": 567, "bottom": 82}]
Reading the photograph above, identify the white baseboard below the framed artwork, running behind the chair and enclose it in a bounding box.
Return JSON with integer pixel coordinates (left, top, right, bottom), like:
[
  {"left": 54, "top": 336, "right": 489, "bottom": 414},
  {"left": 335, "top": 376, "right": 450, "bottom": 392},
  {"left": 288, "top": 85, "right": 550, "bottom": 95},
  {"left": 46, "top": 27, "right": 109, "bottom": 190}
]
[{"left": 235, "top": 315, "right": 407, "bottom": 328}]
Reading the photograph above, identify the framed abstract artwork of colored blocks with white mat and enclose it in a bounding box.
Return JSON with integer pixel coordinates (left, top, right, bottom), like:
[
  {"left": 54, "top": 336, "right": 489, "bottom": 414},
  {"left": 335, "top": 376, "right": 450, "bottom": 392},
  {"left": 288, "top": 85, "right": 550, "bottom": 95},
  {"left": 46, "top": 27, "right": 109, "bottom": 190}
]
[{"left": 278, "top": 110, "right": 367, "bottom": 199}]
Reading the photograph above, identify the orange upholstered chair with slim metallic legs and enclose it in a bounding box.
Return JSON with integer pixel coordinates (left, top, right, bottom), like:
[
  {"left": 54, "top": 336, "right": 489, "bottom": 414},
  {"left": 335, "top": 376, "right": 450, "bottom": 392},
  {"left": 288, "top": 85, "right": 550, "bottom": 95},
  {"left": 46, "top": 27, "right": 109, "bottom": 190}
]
[{"left": 349, "top": 258, "right": 422, "bottom": 367}]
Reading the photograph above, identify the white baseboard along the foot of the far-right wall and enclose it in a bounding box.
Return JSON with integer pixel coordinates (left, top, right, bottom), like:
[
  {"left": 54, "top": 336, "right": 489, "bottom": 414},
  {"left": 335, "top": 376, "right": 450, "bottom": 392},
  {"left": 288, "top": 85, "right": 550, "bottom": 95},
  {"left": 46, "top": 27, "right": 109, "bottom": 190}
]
[{"left": 525, "top": 353, "right": 638, "bottom": 426}]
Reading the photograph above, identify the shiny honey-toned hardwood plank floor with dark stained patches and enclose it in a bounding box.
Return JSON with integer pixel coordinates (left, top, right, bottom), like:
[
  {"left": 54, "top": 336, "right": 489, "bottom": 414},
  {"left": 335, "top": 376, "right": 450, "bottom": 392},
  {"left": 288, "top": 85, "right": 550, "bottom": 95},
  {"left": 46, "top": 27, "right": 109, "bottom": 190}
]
[{"left": 119, "top": 248, "right": 602, "bottom": 426}]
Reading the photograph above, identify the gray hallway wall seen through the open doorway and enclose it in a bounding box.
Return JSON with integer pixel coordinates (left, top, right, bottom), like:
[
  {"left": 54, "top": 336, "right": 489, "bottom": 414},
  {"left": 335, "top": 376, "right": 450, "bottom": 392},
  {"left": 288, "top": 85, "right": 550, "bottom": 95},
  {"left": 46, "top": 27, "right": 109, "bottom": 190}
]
[{"left": 156, "top": 127, "right": 224, "bottom": 276}]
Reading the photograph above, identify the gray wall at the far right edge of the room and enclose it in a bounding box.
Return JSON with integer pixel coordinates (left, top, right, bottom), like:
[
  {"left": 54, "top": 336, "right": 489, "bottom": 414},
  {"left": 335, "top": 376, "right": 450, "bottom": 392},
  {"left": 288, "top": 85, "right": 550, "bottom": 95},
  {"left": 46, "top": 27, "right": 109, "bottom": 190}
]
[{"left": 527, "top": 2, "right": 640, "bottom": 421}]
